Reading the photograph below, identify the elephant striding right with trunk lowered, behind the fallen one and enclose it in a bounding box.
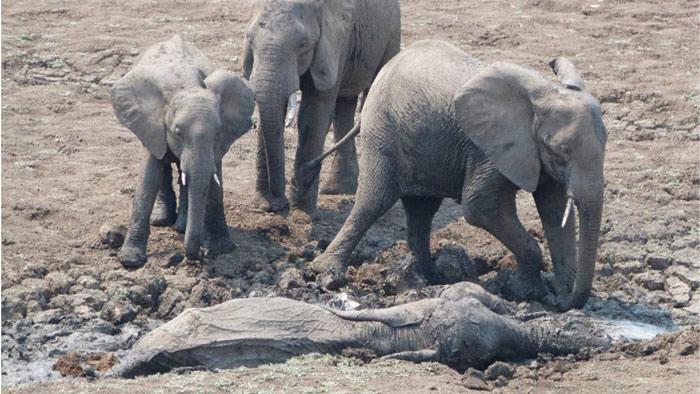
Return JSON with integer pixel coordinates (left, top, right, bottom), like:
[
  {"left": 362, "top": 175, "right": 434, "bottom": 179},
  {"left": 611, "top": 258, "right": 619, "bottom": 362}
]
[{"left": 313, "top": 40, "right": 607, "bottom": 309}]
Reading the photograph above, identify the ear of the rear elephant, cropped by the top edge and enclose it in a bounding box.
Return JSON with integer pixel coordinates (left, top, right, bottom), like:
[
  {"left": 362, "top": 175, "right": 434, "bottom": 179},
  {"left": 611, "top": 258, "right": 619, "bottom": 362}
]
[{"left": 311, "top": 0, "right": 355, "bottom": 91}]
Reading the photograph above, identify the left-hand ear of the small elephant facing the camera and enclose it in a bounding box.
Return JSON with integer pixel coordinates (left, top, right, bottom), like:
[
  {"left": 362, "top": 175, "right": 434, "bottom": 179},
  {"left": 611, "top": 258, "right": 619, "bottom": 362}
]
[{"left": 111, "top": 66, "right": 168, "bottom": 160}]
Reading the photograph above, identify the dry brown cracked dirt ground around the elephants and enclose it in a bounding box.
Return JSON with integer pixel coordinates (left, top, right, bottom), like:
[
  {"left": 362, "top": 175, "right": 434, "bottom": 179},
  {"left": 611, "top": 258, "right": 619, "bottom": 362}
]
[{"left": 2, "top": 0, "right": 700, "bottom": 392}]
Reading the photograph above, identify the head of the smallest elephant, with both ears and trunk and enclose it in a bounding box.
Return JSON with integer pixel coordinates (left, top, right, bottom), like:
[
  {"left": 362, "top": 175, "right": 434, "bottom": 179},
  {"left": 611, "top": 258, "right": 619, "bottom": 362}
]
[{"left": 111, "top": 66, "right": 255, "bottom": 259}]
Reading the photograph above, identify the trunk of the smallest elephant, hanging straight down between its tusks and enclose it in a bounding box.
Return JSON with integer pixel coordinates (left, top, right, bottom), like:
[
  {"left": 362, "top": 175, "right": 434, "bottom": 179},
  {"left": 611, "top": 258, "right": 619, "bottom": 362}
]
[{"left": 183, "top": 149, "right": 215, "bottom": 260}]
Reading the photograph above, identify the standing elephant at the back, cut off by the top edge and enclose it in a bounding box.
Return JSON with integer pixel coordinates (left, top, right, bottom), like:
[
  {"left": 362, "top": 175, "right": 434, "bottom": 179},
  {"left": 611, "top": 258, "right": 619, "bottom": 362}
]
[{"left": 243, "top": 0, "right": 401, "bottom": 213}]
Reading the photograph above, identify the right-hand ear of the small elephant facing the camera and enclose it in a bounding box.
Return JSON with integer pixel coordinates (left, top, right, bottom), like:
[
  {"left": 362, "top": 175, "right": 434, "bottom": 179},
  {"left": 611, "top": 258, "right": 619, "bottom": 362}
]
[{"left": 204, "top": 70, "right": 255, "bottom": 150}]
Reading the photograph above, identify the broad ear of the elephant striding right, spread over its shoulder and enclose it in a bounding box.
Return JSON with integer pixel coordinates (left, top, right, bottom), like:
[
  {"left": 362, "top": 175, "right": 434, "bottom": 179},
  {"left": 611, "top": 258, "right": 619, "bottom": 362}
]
[{"left": 454, "top": 63, "right": 548, "bottom": 192}]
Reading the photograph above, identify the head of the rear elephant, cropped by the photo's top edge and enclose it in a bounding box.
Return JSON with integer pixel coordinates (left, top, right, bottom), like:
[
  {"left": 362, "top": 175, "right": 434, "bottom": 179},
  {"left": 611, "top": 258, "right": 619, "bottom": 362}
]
[{"left": 243, "top": 0, "right": 354, "bottom": 195}]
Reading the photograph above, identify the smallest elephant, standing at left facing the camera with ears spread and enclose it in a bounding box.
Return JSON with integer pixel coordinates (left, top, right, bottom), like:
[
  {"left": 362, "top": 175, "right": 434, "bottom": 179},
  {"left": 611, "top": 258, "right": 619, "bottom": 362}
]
[{"left": 112, "top": 35, "right": 255, "bottom": 268}]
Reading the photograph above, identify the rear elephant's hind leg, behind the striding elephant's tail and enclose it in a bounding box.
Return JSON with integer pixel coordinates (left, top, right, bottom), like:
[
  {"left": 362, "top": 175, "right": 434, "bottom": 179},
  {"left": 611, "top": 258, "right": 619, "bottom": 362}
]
[{"left": 321, "top": 97, "right": 358, "bottom": 194}]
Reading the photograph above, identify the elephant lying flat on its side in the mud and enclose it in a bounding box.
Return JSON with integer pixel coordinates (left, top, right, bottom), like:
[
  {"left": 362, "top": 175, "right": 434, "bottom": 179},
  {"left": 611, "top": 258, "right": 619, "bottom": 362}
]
[{"left": 109, "top": 282, "right": 609, "bottom": 377}]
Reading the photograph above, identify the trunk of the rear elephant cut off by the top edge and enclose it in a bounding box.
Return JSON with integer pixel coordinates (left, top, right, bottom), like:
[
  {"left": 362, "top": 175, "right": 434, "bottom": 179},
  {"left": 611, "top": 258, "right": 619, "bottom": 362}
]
[{"left": 251, "top": 48, "right": 299, "bottom": 197}]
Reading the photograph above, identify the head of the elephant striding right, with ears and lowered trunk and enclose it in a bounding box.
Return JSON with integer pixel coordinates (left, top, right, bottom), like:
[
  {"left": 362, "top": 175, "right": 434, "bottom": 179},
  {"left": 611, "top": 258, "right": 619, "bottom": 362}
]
[{"left": 454, "top": 59, "right": 607, "bottom": 309}]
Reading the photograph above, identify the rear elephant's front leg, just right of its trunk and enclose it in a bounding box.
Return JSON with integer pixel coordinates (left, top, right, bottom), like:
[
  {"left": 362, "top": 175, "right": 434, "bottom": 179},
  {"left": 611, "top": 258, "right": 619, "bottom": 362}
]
[{"left": 291, "top": 78, "right": 338, "bottom": 215}]
